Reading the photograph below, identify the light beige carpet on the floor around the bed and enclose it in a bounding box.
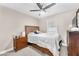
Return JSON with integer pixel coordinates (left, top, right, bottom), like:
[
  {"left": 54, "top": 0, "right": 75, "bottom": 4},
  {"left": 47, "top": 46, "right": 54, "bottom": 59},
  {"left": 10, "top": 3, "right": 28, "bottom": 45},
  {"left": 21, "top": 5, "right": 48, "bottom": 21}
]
[{"left": 1, "top": 46, "right": 67, "bottom": 56}]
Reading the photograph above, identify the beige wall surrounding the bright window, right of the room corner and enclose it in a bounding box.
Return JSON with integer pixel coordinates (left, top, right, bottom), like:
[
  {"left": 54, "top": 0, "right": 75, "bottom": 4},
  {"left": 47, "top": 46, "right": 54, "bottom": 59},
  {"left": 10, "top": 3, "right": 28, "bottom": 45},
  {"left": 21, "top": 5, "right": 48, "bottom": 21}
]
[{"left": 40, "top": 10, "right": 75, "bottom": 45}]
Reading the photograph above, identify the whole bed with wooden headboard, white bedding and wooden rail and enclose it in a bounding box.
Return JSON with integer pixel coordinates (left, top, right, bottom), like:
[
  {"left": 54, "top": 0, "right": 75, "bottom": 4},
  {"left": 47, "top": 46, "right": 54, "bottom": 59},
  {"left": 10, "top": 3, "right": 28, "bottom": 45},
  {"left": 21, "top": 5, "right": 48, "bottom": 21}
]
[{"left": 25, "top": 26, "right": 60, "bottom": 56}]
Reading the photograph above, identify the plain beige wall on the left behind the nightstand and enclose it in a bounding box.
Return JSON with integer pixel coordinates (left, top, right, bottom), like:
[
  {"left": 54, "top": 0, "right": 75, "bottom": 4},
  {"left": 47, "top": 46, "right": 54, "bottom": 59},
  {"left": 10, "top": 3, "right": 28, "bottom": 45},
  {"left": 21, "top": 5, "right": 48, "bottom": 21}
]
[{"left": 0, "top": 6, "right": 38, "bottom": 52}]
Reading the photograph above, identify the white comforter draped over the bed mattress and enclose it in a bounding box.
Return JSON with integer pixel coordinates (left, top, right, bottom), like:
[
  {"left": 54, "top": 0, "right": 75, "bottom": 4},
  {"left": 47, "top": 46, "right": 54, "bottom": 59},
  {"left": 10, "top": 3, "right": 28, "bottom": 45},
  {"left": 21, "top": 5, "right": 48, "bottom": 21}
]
[{"left": 28, "top": 33, "right": 60, "bottom": 56}]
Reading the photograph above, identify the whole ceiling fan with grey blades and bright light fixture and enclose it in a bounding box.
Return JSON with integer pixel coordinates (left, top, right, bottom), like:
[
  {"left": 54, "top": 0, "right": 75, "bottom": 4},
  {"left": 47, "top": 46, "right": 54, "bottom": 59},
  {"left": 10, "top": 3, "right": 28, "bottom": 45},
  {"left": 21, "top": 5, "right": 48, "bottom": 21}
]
[{"left": 30, "top": 3, "right": 56, "bottom": 16}]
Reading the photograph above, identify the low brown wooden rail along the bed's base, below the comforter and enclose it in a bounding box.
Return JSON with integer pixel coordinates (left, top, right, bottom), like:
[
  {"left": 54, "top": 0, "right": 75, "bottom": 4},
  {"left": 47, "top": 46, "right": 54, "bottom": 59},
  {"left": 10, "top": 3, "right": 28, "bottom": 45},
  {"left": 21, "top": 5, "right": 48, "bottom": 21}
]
[{"left": 29, "top": 43, "right": 53, "bottom": 56}]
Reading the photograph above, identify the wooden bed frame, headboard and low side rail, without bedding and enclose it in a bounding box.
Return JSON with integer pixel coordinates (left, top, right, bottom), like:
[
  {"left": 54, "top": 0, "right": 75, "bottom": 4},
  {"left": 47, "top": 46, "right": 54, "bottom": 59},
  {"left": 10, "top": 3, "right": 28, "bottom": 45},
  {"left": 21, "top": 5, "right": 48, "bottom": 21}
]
[{"left": 25, "top": 26, "right": 53, "bottom": 56}]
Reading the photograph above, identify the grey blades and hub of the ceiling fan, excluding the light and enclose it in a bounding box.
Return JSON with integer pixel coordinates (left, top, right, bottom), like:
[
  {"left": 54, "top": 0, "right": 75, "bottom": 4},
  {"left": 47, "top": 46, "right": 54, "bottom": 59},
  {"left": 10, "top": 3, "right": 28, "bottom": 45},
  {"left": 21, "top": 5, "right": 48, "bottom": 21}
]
[{"left": 30, "top": 3, "right": 56, "bottom": 15}]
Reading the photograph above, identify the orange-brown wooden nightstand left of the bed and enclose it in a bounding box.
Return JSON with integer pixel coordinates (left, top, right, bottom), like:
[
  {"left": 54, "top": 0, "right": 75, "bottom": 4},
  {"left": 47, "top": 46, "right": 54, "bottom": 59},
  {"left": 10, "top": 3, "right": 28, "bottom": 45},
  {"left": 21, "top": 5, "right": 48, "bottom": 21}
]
[{"left": 13, "top": 37, "right": 27, "bottom": 51}]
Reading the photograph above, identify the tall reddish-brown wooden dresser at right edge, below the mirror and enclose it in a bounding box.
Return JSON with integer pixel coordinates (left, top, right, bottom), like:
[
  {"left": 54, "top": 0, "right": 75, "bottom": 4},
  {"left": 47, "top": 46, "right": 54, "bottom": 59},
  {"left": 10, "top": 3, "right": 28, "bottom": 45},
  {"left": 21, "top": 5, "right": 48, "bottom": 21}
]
[{"left": 68, "top": 31, "right": 79, "bottom": 56}]
